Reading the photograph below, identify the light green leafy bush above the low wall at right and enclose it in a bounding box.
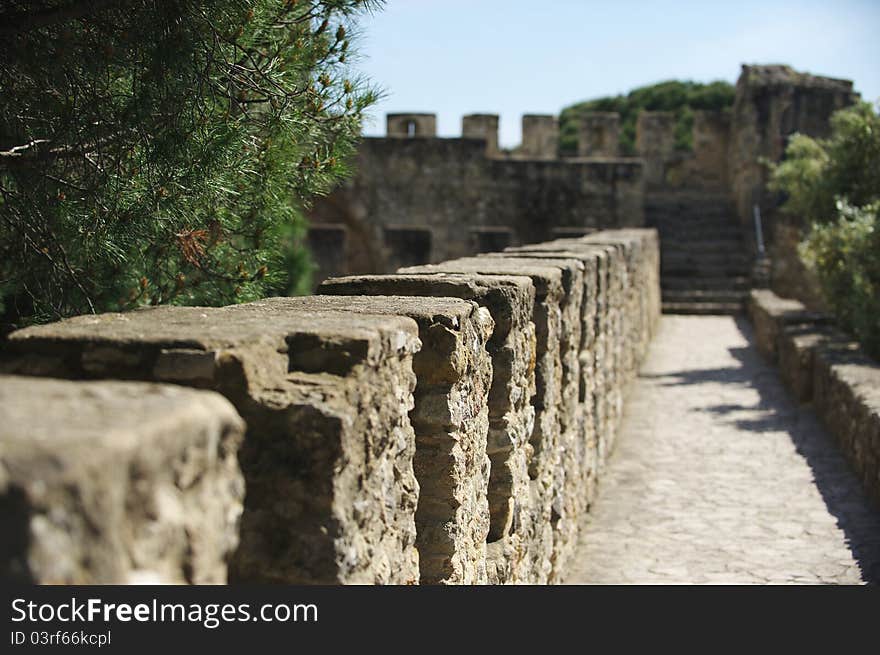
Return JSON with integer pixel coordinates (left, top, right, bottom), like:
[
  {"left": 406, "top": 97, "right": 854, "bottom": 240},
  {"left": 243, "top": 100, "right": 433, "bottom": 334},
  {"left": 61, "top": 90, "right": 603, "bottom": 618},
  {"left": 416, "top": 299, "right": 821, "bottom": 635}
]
[{"left": 770, "top": 102, "right": 880, "bottom": 357}]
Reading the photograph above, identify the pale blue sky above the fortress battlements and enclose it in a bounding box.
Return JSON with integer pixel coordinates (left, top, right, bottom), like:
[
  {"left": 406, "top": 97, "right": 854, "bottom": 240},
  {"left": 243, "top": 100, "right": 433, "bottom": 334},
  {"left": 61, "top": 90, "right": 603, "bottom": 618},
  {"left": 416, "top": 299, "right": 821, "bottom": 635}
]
[{"left": 356, "top": 0, "right": 880, "bottom": 146}]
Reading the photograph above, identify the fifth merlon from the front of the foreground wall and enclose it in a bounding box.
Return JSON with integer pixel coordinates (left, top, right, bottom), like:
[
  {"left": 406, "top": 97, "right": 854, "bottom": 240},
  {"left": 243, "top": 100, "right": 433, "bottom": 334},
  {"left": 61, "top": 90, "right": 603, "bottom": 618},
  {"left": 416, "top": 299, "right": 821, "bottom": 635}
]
[{"left": 399, "top": 257, "right": 563, "bottom": 583}]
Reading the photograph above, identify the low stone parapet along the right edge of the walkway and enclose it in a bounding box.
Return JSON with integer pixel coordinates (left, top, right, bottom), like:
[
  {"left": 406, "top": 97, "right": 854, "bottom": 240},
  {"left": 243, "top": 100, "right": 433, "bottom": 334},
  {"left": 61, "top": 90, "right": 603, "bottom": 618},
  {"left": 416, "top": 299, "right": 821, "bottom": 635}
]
[{"left": 749, "top": 290, "right": 880, "bottom": 506}]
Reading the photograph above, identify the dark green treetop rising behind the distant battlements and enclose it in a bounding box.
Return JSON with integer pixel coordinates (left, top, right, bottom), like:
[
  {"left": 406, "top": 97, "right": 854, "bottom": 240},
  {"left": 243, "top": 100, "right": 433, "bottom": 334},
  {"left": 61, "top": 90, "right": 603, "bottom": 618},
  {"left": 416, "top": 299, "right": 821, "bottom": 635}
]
[{"left": 559, "top": 80, "right": 734, "bottom": 155}]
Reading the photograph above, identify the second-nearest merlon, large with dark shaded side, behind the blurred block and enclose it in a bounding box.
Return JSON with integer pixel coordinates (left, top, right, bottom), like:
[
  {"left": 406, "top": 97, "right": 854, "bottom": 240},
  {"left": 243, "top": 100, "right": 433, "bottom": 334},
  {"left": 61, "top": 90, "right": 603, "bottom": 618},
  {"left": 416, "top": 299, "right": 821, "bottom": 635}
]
[{"left": 4, "top": 299, "right": 419, "bottom": 583}]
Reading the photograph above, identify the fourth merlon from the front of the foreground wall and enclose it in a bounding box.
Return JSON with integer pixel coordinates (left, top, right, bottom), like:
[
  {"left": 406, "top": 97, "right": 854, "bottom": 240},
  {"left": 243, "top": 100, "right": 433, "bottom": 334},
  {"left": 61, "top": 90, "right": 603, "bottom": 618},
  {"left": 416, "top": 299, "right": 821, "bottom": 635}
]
[{"left": 319, "top": 273, "right": 535, "bottom": 584}]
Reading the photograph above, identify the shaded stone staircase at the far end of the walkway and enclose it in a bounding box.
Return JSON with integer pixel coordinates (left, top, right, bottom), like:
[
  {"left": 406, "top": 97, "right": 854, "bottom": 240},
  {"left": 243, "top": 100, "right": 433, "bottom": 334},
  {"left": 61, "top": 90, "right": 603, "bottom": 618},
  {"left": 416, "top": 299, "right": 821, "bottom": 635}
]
[{"left": 645, "top": 192, "right": 753, "bottom": 314}]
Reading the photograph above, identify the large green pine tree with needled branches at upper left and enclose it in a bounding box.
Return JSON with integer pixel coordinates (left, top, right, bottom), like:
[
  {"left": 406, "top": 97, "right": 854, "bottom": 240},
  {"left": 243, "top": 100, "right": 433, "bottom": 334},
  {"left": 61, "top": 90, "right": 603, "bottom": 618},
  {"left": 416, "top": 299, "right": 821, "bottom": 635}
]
[{"left": 0, "top": 0, "right": 377, "bottom": 331}]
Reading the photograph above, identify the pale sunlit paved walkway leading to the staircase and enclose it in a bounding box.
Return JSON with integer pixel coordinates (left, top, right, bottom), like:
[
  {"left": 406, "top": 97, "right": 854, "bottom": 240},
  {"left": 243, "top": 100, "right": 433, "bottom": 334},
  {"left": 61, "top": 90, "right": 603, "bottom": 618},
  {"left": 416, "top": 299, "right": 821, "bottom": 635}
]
[{"left": 567, "top": 316, "right": 880, "bottom": 584}]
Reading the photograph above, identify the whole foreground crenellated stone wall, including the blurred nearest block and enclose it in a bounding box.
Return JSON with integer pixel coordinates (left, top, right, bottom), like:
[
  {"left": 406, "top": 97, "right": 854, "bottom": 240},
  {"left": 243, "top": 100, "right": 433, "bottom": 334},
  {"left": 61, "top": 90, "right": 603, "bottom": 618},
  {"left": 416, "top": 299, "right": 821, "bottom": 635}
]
[{"left": 0, "top": 229, "right": 660, "bottom": 584}]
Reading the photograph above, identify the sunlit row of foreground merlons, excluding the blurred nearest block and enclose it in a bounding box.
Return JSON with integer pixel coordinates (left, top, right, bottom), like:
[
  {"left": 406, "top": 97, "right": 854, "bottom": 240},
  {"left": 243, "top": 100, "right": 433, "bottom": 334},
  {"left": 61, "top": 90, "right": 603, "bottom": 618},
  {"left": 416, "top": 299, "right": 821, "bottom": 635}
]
[{"left": 0, "top": 229, "right": 660, "bottom": 584}]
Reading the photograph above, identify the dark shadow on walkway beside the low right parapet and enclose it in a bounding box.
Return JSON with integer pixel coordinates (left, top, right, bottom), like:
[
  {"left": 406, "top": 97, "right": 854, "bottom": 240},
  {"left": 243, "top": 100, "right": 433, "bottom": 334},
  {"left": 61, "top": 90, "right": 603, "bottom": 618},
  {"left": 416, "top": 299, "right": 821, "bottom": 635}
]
[{"left": 641, "top": 317, "right": 880, "bottom": 584}]
